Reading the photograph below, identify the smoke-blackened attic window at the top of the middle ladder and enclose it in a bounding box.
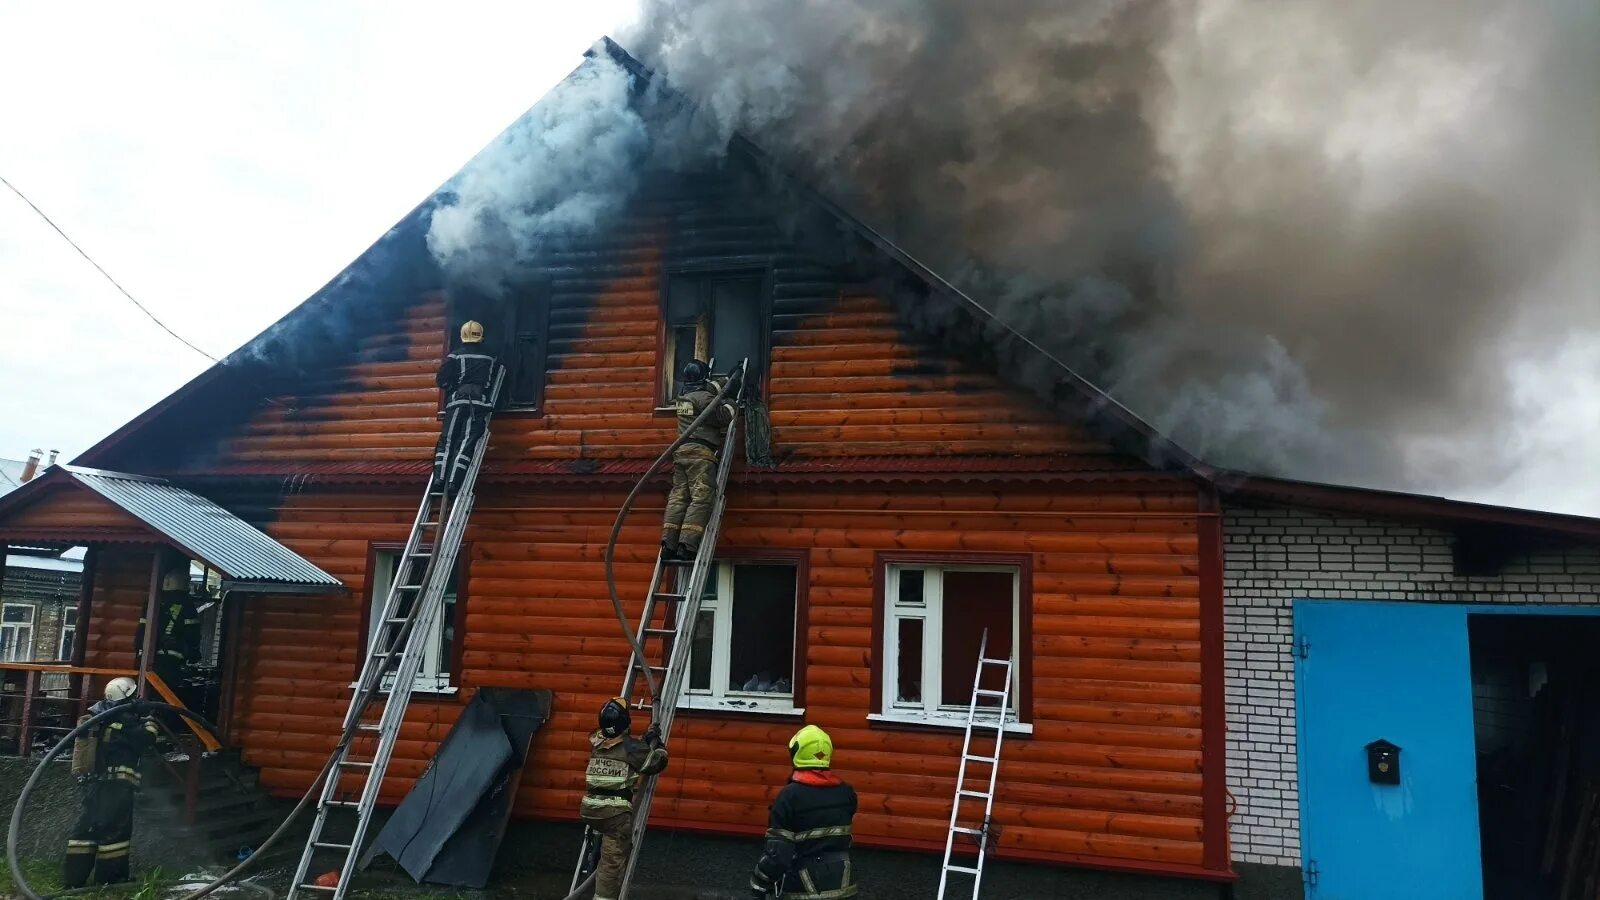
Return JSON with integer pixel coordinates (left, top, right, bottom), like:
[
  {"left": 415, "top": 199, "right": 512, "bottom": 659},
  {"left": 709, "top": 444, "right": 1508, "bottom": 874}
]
[{"left": 661, "top": 272, "right": 768, "bottom": 405}]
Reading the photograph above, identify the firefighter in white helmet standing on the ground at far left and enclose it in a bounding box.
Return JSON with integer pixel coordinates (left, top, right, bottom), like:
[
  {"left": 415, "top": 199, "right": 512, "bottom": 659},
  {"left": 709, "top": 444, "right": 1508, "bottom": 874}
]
[{"left": 61, "top": 677, "right": 160, "bottom": 889}]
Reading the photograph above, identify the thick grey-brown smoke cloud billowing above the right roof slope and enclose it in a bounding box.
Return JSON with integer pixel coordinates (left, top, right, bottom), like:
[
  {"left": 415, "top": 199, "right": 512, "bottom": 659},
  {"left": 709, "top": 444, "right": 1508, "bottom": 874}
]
[{"left": 622, "top": 0, "right": 1600, "bottom": 488}]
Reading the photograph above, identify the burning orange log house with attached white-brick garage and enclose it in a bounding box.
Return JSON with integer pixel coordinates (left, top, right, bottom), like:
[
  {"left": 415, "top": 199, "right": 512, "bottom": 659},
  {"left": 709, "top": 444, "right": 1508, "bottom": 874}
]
[{"left": 0, "top": 36, "right": 1600, "bottom": 897}]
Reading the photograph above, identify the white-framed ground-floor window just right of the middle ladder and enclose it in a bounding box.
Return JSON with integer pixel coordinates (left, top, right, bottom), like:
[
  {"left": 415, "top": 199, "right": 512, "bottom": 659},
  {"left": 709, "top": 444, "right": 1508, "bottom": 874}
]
[{"left": 680, "top": 562, "right": 797, "bottom": 713}]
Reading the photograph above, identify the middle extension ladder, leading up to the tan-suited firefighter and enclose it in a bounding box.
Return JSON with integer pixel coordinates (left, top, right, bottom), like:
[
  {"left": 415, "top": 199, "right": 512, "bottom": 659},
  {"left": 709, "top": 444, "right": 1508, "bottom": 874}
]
[{"left": 570, "top": 365, "right": 744, "bottom": 900}]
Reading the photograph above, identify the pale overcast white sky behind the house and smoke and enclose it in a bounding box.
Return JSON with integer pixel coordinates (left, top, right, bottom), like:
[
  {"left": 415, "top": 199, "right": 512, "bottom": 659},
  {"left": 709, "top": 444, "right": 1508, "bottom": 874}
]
[{"left": 0, "top": 0, "right": 1600, "bottom": 516}]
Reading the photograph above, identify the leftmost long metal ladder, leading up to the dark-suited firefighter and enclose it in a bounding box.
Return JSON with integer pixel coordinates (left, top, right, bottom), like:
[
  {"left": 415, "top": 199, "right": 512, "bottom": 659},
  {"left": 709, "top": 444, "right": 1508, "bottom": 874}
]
[{"left": 290, "top": 367, "right": 506, "bottom": 900}]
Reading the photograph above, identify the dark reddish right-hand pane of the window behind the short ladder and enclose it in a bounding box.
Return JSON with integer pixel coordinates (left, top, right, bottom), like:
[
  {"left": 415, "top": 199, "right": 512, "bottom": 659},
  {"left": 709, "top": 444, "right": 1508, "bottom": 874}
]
[{"left": 939, "top": 572, "right": 1016, "bottom": 706}]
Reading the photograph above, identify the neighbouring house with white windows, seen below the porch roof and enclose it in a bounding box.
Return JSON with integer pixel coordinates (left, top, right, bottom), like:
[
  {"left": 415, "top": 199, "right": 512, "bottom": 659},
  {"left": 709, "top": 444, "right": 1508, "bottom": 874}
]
[{"left": 0, "top": 548, "right": 85, "bottom": 663}]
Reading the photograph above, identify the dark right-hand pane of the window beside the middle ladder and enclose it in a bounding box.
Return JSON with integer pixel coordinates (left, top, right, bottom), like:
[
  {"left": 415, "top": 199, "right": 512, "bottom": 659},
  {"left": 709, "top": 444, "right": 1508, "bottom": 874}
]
[{"left": 728, "top": 565, "right": 795, "bottom": 695}]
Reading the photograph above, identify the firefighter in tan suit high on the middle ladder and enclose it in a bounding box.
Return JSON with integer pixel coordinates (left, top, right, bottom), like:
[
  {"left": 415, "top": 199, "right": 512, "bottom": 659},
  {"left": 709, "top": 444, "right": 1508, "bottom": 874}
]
[{"left": 661, "top": 359, "right": 738, "bottom": 559}]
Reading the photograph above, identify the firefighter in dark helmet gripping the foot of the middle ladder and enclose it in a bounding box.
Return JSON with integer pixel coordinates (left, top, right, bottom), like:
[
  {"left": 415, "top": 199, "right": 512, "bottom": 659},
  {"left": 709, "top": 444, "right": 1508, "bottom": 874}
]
[{"left": 578, "top": 697, "right": 667, "bottom": 900}]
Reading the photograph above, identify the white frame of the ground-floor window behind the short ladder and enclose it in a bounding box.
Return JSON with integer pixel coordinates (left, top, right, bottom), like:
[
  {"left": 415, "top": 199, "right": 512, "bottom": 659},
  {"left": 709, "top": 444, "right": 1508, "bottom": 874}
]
[{"left": 867, "top": 562, "right": 1034, "bottom": 720}]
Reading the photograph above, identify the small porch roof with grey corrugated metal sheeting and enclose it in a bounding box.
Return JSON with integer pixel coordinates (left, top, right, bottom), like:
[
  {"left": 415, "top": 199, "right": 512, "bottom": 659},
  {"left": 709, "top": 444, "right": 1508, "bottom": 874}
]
[{"left": 0, "top": 466, "right": 346, "bottom": 594}]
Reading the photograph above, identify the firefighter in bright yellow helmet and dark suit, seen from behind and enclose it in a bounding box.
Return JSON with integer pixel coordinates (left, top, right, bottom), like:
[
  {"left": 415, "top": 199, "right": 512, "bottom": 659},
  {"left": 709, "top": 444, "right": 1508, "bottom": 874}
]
[{"left": 750, "top": 725, "right": 856, "bottom": 900}]
